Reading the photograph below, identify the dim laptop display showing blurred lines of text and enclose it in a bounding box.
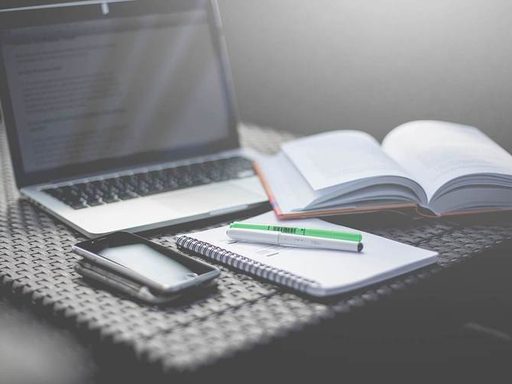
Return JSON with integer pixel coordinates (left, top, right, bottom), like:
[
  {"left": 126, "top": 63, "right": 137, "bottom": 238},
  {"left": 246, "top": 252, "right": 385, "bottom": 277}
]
[{"left": 1, "top": 0, "right": 240, "bottom": 186}]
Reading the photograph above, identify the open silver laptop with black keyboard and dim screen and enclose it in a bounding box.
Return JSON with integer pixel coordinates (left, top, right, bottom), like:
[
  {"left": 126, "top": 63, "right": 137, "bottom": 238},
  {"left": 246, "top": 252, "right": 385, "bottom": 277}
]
[{"left": 0, "top": 0, "right": 266, "bottom": 237}]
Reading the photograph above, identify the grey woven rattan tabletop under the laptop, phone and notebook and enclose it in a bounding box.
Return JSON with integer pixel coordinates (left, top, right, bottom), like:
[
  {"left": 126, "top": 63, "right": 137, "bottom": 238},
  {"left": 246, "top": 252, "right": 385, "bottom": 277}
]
[{"left": 0, "top": 127, "right": 512, "bottom": 371}]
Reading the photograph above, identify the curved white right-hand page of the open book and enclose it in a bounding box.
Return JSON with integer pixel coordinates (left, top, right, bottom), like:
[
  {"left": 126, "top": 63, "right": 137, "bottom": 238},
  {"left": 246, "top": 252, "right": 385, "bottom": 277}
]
[{"left": 382, "top": 120, "right": 512, "bottom": 200}]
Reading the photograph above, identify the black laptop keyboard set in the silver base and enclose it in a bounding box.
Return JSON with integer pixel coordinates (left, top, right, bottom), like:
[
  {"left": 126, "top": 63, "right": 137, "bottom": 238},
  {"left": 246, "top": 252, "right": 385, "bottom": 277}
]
[{"left": 43, "top": 156, "right": 254, "bottom": 209}]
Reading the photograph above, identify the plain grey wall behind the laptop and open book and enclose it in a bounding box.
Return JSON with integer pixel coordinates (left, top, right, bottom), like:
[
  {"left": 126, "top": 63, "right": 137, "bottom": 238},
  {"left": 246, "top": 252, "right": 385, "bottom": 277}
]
[{"left": 220, "top": 0, "right": 512, "bottom": 150}]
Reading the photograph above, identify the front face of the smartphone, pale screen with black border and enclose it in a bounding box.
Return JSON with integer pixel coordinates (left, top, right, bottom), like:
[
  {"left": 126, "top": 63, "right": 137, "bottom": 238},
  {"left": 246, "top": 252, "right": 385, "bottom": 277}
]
[{"left": 73, "top": 233, "right": 216, "bottom": 287}]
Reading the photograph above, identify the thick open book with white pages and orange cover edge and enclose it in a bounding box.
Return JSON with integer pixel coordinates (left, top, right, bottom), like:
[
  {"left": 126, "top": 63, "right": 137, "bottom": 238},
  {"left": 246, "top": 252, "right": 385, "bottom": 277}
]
[{"left": 256, "top": 121, "right": 512, "bottom": 218}]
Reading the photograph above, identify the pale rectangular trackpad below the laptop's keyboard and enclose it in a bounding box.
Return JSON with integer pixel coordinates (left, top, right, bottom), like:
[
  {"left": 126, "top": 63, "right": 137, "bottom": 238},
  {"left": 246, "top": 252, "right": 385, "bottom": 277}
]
[{"left": 152, "top": 182, "right": 262, "bottom": 216}]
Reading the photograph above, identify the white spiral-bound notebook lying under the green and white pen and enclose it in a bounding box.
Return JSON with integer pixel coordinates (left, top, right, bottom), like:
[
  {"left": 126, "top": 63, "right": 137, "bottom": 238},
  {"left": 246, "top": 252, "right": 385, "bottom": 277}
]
[{"left": 176, "top": 212, "right": 437, "bottom": 297}]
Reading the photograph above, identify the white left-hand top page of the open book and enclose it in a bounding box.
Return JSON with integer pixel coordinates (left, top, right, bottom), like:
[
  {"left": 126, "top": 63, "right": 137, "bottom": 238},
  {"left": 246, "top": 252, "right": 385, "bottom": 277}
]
[{"left": 281, "top": 131, "right": 409, "bottom": 191}]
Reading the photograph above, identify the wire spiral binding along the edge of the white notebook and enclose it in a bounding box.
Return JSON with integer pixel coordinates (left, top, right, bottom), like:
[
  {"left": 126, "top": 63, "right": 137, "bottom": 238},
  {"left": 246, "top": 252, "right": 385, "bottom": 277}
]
[{"left": 176, "top": 236, "right": 320, "bottom": 293}]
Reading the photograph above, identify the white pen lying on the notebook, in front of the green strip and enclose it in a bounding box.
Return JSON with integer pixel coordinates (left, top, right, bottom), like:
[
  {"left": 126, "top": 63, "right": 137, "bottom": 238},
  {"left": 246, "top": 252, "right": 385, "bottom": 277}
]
[{"left": 226, "top": 228, "right": 363, "bottom": 252}]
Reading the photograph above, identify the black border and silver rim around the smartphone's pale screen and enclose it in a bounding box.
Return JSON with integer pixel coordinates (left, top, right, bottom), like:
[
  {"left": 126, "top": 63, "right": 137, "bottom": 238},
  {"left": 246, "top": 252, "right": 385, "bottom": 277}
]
[{"left": 72, "top": 232, "right": 220, "bottom": 294}]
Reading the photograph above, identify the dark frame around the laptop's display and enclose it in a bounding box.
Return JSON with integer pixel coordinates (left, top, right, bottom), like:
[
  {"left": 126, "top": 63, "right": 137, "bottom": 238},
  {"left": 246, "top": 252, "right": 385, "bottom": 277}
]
[{"left": 0, "top": 0, "right": 240, "bottom": 188}]
